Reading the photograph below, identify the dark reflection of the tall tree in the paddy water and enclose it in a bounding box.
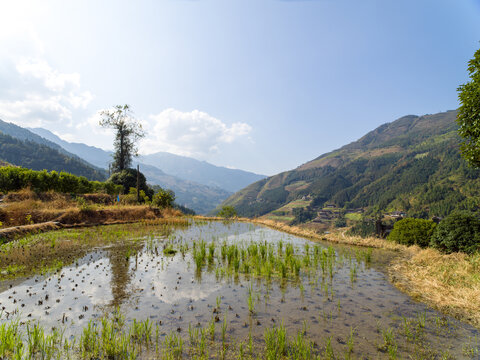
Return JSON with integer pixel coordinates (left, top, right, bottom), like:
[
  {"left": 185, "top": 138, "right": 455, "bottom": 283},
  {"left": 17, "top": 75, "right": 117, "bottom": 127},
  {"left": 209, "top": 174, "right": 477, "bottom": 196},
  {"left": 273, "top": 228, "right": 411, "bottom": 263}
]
[{"left": 107, "top": 242, "right": 143, "bottom": 306}]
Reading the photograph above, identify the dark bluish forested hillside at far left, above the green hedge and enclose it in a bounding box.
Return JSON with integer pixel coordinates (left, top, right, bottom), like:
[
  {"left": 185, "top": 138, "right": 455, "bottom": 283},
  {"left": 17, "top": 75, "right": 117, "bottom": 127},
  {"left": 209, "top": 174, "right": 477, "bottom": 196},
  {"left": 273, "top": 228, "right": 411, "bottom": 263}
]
[{"left": 0, "top": 132, "right": 105, "bottom": 181}]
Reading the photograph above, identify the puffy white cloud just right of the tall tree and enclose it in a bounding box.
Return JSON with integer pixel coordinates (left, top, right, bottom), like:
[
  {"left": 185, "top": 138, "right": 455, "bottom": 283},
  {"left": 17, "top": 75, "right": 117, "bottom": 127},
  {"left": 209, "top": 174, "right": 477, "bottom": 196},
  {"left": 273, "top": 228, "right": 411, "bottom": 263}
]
[{"left": 141, "top": 108, "right": 252, "bottom": 158}]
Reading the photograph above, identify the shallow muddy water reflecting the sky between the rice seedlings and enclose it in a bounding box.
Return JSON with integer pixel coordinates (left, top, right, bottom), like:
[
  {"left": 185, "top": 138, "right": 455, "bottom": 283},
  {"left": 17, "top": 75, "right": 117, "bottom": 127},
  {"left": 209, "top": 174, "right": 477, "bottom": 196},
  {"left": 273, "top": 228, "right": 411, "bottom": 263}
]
[{"left": 0, "top": 222, "right": 478, "bottom": 359}]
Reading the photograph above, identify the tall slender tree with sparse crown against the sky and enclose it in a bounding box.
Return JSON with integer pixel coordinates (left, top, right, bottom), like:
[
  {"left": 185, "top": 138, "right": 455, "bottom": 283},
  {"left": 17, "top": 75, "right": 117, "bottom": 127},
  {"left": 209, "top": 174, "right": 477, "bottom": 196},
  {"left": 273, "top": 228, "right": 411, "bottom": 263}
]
[{"left": 100, "top": 104, "right": 145, "bottom": 172}]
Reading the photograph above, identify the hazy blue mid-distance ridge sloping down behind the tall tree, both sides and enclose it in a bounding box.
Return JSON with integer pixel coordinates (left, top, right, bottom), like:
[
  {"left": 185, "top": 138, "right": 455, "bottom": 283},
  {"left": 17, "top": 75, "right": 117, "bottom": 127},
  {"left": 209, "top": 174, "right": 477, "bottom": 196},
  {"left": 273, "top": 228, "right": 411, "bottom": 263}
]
[{"left": 30, "top": 128, "right": 232, "bottom": 214}]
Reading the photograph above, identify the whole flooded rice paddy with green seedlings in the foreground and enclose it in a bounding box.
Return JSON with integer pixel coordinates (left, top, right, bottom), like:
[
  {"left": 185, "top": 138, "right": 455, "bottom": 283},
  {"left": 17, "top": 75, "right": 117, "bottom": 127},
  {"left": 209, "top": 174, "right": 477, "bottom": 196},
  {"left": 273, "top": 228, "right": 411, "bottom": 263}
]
[{"left": 0, "top": 221, "right": 480, "bottom": 359}]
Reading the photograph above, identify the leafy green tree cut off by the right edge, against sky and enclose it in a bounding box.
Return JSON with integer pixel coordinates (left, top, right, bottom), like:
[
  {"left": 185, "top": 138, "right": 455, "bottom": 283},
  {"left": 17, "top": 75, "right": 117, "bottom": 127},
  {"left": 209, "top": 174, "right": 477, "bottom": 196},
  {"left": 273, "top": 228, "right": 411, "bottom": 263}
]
[{"left": 457, "top": 49, "right": 480, "bottom": 167}]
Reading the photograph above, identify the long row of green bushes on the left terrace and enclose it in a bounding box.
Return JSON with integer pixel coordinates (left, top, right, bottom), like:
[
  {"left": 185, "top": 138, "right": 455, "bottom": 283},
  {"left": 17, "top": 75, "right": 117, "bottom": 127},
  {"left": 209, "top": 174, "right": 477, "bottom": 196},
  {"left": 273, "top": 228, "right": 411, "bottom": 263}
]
[{"left": 0, "top": 166, "right": 119, "bottom": 195}]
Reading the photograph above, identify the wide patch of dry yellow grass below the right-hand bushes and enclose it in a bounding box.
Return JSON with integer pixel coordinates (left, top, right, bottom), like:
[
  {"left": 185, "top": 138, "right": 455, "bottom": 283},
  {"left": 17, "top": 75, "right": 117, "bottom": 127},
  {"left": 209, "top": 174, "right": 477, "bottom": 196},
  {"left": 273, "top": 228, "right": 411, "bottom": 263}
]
[{"left": 389, "top": 249, "right": 480, "bottom": 327}]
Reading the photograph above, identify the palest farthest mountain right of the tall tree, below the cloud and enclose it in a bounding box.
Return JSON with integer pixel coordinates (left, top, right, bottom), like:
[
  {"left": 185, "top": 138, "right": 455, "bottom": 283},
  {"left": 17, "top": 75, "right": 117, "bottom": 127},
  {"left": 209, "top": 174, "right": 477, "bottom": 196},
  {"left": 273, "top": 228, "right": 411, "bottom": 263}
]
[{"left": 140, "top": 152, "right": 265, "bottom": 192}]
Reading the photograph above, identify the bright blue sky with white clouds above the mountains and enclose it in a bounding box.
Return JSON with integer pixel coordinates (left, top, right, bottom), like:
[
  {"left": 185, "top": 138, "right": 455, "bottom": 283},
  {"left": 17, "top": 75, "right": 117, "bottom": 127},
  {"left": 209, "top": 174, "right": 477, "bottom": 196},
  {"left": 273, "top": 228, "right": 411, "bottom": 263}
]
[{"left": 0, "top": 0, "right": 480, "bottom": 175}]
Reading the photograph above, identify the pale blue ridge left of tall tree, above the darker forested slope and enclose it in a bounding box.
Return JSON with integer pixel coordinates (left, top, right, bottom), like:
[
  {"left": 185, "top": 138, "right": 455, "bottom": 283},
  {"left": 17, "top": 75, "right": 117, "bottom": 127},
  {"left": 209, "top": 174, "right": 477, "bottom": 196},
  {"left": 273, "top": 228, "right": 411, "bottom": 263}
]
[{"left": 29, "top": 128, "right": 112, "bottom": 169}]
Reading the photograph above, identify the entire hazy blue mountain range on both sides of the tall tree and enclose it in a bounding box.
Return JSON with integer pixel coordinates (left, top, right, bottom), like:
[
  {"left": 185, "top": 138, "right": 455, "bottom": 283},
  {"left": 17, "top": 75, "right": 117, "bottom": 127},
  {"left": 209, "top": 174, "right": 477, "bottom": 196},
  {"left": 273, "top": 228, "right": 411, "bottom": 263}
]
[{"left": 0, "top": 120, "right": 263, "bottom": 214}]
